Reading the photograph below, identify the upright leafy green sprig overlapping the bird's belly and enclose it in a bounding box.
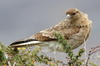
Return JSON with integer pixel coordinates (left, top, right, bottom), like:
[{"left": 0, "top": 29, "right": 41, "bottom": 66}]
[{"left": 55, "top": 33, "right": 84, "bottom": 66}]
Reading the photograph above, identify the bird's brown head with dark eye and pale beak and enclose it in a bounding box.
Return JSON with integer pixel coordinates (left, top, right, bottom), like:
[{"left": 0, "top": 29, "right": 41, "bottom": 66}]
[{"left": 66, "top": 8, "right": 82, "bottom": 20}]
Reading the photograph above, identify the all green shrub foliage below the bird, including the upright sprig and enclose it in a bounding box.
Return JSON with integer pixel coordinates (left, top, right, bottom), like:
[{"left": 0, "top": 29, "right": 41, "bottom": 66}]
[{"left": 0, "top": 33, "right": 97, "bottom": 66}]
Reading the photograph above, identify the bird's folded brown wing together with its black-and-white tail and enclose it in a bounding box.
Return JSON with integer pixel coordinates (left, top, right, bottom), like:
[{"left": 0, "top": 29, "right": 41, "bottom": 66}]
[{"left": 11, "top": 20, "right": 80, "bottom": 47}]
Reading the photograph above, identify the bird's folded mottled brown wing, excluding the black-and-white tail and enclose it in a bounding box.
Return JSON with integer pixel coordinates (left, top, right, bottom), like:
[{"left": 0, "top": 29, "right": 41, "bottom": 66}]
[{"left": 30, "top": 21, "right": 80, "bottom": 41}]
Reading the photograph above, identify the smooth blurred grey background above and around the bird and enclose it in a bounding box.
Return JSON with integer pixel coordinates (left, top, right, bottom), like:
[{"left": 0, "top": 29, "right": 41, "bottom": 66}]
[{"left": 0, "top": 0, "right": 100, "bottom": 64}]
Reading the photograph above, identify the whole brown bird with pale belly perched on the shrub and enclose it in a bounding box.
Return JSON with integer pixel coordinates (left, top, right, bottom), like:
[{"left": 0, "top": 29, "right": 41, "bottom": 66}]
[{"left": 10, "top": 8, "right": 92, "bottom": 51}]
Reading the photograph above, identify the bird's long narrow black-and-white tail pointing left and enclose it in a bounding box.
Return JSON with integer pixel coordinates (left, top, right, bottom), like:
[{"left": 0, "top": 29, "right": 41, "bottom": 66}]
[{"left": 10, "top": 39, "right": 42, "bottom": 47}]
